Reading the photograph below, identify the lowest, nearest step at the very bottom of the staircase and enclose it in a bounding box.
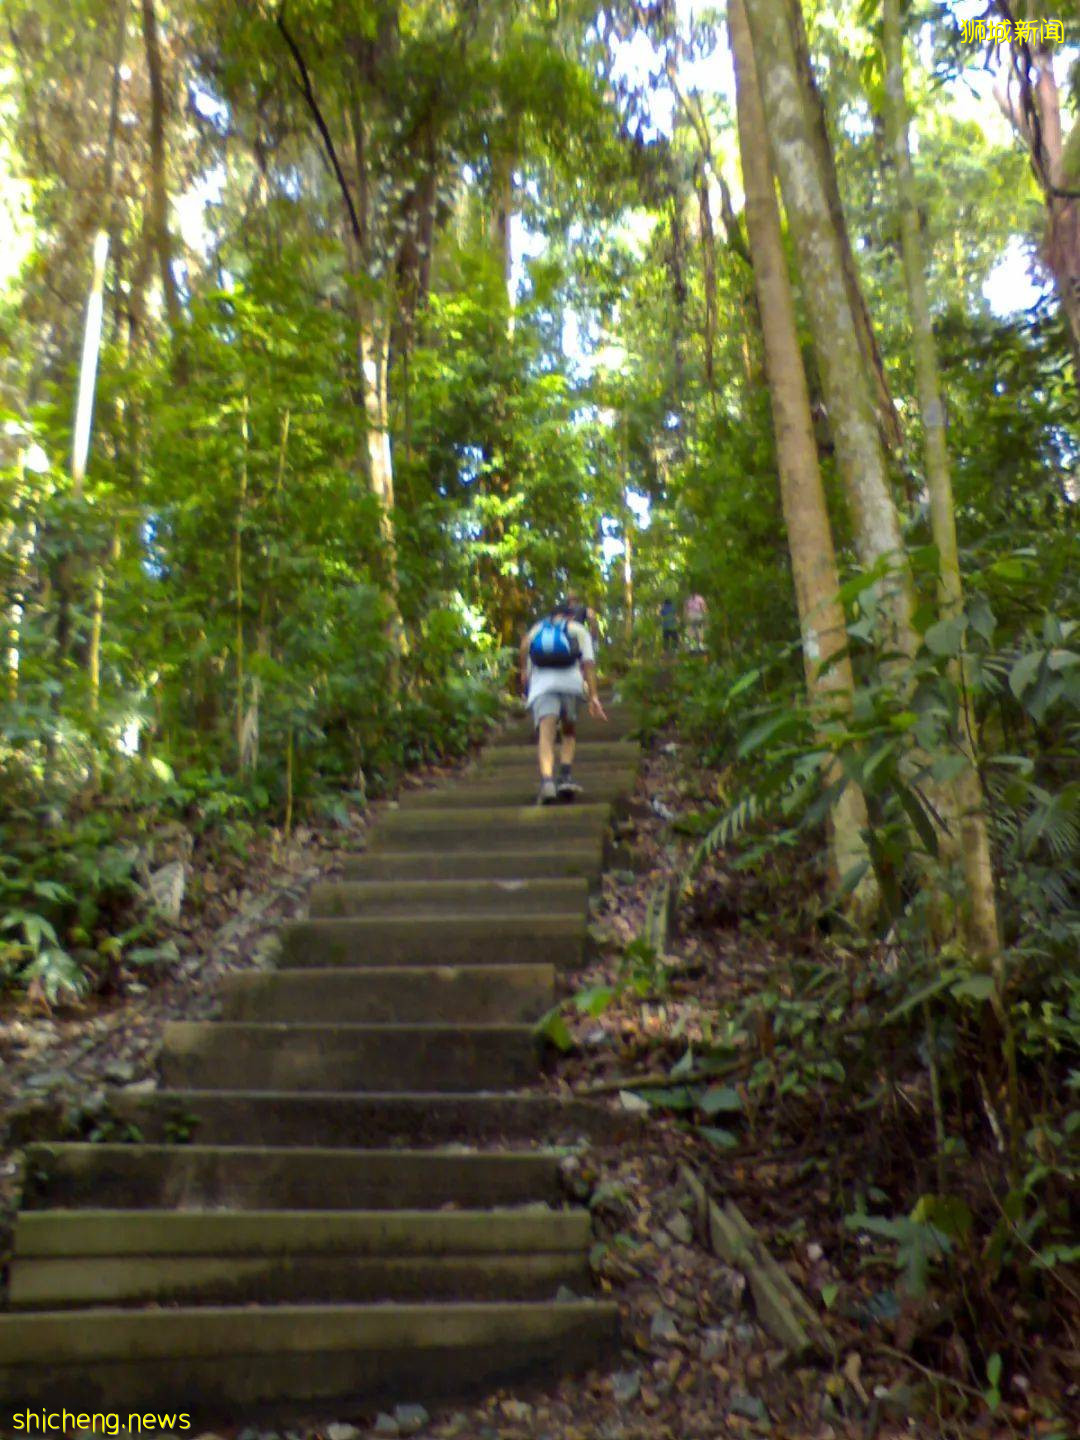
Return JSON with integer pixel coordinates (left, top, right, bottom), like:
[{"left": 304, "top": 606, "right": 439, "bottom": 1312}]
[{"left": 0, "top": 1300, "right": 618, "bottom": 1411}]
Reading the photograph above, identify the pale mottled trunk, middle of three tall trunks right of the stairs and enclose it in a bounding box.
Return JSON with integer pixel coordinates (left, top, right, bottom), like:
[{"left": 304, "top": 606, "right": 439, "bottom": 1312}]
[{"left": 746, "top": 0, "right": 916, "bottom": 655}]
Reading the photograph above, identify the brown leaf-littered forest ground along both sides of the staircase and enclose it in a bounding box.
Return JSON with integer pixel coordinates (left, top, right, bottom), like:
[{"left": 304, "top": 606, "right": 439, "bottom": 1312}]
[{"left": 0, "top": 742, "right": 1080, "bottom": 1440}]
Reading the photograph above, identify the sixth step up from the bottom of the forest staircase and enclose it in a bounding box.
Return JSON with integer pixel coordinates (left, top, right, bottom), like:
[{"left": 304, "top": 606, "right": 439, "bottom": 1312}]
[{"left": 219, "top": 965, "right": 554, "bottom": 1025}]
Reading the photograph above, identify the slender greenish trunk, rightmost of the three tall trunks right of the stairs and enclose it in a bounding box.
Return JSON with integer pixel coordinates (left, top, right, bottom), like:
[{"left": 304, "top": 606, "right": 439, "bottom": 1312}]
[{"left": 881, "top": 0, "right": 1001, "bottom": 958}]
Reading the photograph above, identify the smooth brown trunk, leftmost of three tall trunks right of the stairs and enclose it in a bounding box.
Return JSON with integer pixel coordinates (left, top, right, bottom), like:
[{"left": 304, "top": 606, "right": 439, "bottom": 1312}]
[{"left": 727, "top": 0, "right": 877, "bottom": 920}]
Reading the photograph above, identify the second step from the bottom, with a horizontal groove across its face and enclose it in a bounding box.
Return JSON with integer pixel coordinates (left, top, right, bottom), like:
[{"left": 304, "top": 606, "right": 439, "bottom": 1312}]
[{"left": 9, "top": 1210, "right": 589, "bottom": 1309}]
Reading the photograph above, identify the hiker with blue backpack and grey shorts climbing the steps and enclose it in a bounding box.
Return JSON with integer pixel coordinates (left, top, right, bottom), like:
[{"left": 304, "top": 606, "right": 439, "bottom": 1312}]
[{"left": 520, "top": 596, "right": 608, "bottom": 805}]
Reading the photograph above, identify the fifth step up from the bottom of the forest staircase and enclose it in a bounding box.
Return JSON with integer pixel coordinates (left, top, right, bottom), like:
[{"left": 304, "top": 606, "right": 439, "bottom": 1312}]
[{"left": 160, "top": 1021, "right": 539, "bottom": 1093}]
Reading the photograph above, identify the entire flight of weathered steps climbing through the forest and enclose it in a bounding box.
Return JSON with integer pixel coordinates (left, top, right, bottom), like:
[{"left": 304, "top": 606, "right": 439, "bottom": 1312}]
[{"left": 0, "top": 708, "right": 638, "bottom": 1423}]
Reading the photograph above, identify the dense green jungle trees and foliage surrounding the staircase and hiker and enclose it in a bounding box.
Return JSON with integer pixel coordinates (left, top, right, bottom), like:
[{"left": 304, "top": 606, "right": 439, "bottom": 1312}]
[{"left": 0, "top": 0, "right": 1080, "bottom": 1433}]
